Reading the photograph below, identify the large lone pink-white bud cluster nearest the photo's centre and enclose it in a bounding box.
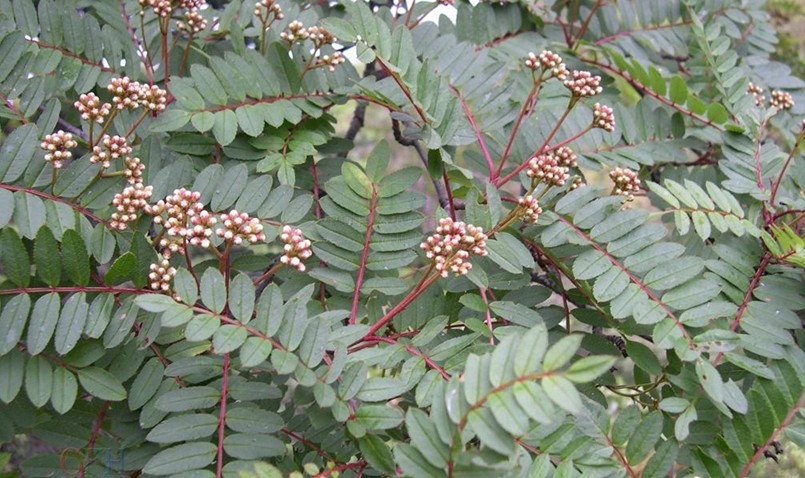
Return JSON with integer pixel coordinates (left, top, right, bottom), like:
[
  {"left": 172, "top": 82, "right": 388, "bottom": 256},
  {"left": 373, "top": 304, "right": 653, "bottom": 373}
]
[{"left": 419, "top": 218, "right": 488, "bottom": 277}]
